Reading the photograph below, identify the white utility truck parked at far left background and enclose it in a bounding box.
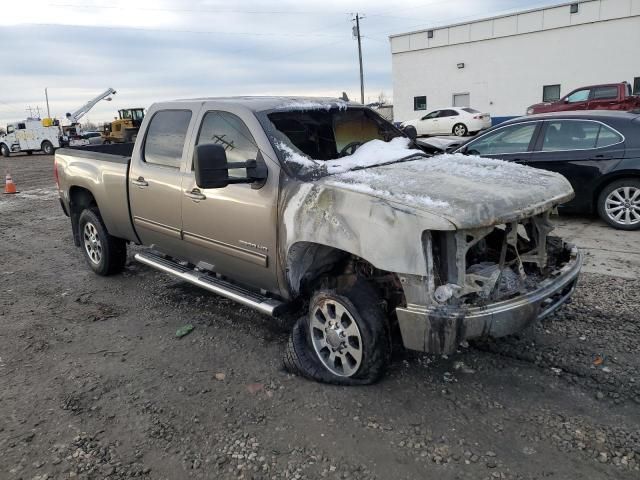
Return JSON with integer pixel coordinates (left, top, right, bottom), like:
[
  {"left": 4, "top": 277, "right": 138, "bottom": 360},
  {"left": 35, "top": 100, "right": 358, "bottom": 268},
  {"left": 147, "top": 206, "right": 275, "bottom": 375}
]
[{"left": 0, "top": 118, "right": 63, "bottom": 157}]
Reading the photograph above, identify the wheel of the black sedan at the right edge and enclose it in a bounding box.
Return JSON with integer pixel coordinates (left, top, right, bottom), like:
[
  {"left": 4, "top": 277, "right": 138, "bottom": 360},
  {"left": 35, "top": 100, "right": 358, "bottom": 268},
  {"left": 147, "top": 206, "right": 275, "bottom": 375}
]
[{"left": 598, "top": 178, "right": 640, "bottom": 230}]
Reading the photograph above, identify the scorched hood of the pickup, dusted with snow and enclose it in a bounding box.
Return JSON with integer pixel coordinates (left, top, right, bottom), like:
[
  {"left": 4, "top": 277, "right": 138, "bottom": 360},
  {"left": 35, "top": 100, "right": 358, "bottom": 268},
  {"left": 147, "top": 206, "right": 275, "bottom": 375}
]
[{"left": 319, "top": 154, "right": 573, "bottom": 228}]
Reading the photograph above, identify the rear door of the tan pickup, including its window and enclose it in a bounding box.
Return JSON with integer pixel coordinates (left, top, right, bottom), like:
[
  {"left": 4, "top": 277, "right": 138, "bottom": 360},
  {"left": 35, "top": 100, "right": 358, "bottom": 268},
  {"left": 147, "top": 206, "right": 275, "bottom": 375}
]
[{"left": 128, "top": 109, "right": 193, "bottom": 256}]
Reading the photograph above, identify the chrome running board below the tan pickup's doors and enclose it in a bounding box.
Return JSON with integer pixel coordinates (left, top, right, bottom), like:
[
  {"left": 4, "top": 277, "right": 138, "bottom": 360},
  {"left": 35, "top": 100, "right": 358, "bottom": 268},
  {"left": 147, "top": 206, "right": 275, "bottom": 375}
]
[{"left": 134, "top": 252, "right": 286, "bottom": 317}]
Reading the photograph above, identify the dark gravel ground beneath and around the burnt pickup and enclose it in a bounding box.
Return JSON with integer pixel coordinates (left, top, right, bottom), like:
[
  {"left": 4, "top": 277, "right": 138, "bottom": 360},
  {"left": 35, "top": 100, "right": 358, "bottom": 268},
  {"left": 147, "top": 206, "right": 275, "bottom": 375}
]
[{"left": 0, "top": 155, "right": 640, "bottom": 480}]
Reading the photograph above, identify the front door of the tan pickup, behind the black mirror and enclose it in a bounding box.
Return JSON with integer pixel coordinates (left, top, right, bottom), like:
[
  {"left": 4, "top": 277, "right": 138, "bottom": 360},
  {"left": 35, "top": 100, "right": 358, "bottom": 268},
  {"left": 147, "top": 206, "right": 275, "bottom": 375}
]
[{"left": 182, "top": 107, "right": 279, "bottom": 292}]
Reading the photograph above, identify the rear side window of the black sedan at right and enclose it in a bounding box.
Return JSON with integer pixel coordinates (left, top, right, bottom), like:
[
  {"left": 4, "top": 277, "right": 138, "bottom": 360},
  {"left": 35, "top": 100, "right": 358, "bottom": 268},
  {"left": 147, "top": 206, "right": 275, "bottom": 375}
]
[{"left": 542, "top": 120, "right": 622, "bottom": 152}]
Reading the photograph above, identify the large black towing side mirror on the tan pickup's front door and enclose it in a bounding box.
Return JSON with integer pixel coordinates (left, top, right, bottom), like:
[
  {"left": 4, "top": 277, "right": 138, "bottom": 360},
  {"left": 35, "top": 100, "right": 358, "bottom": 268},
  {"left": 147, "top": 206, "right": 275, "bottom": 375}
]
[{"left": 193, "top": 143, "right": 268, "bottom": 189}]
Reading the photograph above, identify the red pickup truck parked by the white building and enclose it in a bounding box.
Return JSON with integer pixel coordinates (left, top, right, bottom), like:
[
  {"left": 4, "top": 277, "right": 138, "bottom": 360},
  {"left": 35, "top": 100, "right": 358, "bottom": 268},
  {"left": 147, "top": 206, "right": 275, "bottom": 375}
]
[{"left": 527, "top": 82, "right": 640, "bottom": 115}]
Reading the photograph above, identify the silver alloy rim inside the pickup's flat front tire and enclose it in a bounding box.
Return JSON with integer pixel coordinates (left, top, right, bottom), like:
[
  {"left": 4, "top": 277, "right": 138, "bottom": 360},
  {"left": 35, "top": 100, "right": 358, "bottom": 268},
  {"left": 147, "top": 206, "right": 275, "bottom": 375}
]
[{"left": 310, "top": 298, "right": 362, "bottom": 377}]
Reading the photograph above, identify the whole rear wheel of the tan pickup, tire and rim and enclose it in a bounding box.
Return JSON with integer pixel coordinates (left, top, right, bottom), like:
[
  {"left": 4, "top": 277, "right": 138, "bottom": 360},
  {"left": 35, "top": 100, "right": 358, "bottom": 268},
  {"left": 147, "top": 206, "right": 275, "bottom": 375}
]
[{"left": 78, "top": 208, "right": 127, "bottom": 276}]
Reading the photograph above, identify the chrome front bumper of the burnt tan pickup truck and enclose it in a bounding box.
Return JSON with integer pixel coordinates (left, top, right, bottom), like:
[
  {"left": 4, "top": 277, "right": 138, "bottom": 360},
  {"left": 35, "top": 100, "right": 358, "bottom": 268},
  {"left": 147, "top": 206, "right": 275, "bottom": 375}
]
[{"left": 396, "top": 247, "right": 582, "bottom": 354}]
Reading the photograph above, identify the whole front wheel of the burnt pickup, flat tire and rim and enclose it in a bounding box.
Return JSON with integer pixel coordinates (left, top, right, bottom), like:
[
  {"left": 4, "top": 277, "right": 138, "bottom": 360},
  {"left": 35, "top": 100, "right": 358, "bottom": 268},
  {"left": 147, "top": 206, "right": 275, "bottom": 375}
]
[{"left": 284, "top": 280, "right": 391, "bottom": 385}]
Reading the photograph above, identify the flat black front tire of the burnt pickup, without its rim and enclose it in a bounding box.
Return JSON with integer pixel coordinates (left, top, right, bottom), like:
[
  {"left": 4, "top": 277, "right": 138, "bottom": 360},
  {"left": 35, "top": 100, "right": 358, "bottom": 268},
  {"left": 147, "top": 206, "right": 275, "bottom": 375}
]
[{"left": 283, "top": 280, "right": 391, "bottom": 386}]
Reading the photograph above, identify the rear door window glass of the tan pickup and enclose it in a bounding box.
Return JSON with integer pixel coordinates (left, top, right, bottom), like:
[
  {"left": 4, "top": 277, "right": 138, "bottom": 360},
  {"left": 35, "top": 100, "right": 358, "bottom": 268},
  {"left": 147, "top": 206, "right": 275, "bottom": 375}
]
[{"left": 144, "top": 110, "right": 191, "bottom": 168}]
